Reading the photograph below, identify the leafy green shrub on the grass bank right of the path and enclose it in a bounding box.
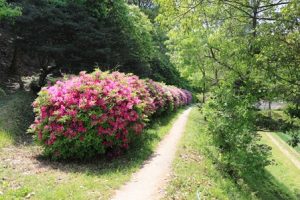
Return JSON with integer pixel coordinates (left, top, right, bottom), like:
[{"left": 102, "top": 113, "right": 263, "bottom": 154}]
[{"left": 204, "top": 80, "right": 270, "bottom": 178}]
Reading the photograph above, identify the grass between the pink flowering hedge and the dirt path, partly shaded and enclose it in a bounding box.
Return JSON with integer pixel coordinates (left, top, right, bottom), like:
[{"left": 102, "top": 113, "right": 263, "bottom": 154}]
[{"left": 0, "top": 109, "right": 184, "bottom": 200}]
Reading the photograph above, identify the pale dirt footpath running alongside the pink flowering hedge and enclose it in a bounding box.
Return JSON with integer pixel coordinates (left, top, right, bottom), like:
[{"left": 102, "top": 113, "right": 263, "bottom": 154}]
[{"left": 112, "top": 108, "right": 191, "bottom": 200}]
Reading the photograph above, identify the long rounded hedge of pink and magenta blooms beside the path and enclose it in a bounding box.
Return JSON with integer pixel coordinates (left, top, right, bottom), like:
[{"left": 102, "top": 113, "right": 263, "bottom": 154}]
[{"left": 29, "top": 70, "right": 192, "bottom": 159}]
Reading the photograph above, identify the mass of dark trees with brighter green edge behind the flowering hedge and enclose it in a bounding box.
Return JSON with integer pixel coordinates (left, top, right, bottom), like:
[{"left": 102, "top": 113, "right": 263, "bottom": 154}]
[{"left": 0, "top": 0, "right": 188, "bottom": 87}]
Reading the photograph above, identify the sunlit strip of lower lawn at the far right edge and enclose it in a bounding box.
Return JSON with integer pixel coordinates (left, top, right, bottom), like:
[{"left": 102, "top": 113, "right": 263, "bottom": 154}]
[{"left": 262, "top": 133, "right": 300, "bottom": 199}]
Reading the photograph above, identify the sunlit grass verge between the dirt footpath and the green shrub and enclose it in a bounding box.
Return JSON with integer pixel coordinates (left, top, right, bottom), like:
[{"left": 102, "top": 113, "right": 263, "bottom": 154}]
[{"left": 166, "top": 108, "right": 250, "bottom": 199}]
